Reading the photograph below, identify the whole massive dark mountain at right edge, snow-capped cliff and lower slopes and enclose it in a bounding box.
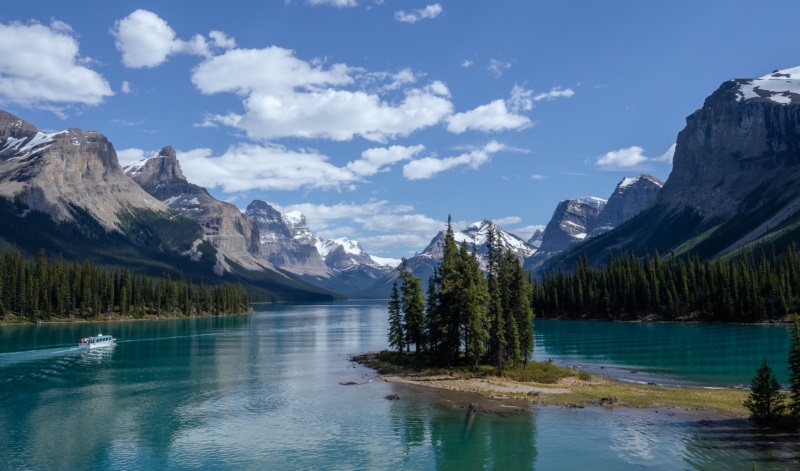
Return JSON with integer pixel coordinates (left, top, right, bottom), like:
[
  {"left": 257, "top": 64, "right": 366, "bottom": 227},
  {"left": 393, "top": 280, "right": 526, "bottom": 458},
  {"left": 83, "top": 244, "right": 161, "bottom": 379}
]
[{"left": 559, "top": 67, "right": 800, "bottom": 272}]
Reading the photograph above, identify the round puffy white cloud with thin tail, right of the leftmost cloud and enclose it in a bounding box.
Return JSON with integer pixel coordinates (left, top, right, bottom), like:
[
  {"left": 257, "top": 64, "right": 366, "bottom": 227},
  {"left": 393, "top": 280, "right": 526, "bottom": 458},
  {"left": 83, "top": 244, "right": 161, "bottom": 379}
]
[{"left": 111, "top": 9, "right": 236, "bottom": 69}]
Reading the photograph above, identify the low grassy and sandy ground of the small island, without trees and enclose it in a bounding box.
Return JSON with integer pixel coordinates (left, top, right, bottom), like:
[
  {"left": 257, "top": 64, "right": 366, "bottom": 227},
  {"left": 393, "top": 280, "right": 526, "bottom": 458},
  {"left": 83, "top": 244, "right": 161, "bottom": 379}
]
[{"left": 353, "top": 351, "right": 749, "bottom": 417}]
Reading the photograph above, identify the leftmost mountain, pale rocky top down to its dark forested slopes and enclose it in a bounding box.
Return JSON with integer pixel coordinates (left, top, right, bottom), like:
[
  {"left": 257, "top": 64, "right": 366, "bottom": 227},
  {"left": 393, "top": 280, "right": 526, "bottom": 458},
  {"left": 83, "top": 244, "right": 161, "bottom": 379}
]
[{"left": 0, "top": 111, "right": 333, "bottom": 300}]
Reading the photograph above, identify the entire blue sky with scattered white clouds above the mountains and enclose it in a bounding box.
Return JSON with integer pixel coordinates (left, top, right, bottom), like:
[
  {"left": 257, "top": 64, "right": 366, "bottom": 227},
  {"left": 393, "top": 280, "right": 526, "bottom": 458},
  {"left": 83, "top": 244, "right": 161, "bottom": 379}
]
[{"left": 0, "top": 0, "right": 800, "bottom": 258}]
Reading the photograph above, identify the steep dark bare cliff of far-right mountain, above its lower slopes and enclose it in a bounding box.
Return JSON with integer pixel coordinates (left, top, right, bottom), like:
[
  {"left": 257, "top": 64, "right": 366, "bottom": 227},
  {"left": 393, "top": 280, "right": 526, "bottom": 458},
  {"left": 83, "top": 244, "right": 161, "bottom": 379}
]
[{"left": 656, "top": 72, "right": 800, "bottom": 220}]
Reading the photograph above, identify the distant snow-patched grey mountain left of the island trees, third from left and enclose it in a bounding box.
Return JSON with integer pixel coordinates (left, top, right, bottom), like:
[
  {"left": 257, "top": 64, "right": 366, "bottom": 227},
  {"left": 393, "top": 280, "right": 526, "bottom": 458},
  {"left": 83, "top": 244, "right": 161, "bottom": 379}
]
[{"left": 245, "top": 200, "right": 393, "bottom": 297}]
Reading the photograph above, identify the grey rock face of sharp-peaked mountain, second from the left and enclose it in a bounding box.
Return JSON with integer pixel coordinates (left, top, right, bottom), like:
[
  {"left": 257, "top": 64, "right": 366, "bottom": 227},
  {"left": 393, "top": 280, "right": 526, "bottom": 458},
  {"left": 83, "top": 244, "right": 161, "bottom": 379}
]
[{"left": 125, "top": 146, "right": 272, "bottom": 271}]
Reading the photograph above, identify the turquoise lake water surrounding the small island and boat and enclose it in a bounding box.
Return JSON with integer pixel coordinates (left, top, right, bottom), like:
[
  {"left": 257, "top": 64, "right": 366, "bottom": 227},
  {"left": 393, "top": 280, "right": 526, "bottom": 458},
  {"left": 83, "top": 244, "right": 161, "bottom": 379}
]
[{"left": 0, "top": 301, "right": 800, "bottom": 471}]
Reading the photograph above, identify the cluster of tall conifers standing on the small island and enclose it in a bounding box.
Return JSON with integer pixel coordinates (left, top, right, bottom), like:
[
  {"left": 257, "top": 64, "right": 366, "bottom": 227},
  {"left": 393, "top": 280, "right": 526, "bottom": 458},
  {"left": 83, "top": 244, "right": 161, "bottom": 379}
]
[{"left": 388, "top": 217, "right": 534, "bottom": 370}]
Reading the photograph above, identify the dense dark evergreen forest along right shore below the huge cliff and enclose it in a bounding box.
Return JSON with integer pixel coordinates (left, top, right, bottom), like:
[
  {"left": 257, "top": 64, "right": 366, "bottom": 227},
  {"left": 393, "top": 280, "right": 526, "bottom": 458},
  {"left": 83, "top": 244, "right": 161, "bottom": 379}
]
[{"left": 533, "top": 247, "right": 800, "bottom": 322}]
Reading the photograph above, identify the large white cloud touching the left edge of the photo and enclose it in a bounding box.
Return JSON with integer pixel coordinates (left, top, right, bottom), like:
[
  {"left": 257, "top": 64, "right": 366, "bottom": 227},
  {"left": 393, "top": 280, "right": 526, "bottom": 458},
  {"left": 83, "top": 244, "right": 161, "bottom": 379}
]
[{"left": 0, "top": 21, "right": 114, "bottom": 108}]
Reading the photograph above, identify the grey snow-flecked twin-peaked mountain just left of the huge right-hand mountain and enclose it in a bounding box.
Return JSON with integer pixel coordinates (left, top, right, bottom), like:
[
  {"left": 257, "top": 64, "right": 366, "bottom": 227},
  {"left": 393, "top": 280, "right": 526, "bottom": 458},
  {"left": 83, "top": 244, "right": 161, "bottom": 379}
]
[{"left": 524, "top": 174, "right": 663, "bottom": 271}]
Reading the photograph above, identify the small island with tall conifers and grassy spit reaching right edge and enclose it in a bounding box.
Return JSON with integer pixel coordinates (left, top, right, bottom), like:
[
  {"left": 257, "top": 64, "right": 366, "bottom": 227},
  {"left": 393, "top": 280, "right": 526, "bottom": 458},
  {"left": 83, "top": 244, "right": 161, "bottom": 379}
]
[{"left": 358, "top": 220, "right": 800, "bottom": 430}]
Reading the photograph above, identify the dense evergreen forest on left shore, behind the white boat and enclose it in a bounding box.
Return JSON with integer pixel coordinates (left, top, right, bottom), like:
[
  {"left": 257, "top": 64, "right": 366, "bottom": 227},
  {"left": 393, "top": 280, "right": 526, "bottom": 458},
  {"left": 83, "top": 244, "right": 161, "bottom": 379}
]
[{"left": 0, "top": 251, "right": 250, "bottom": 322}]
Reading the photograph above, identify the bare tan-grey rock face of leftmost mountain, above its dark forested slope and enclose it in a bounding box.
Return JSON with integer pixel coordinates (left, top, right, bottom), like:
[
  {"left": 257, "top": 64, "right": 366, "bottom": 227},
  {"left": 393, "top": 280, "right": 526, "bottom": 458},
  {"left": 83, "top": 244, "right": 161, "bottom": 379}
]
[{"left": 0, "top": 111, "right": 169, "bottom": 231}]
